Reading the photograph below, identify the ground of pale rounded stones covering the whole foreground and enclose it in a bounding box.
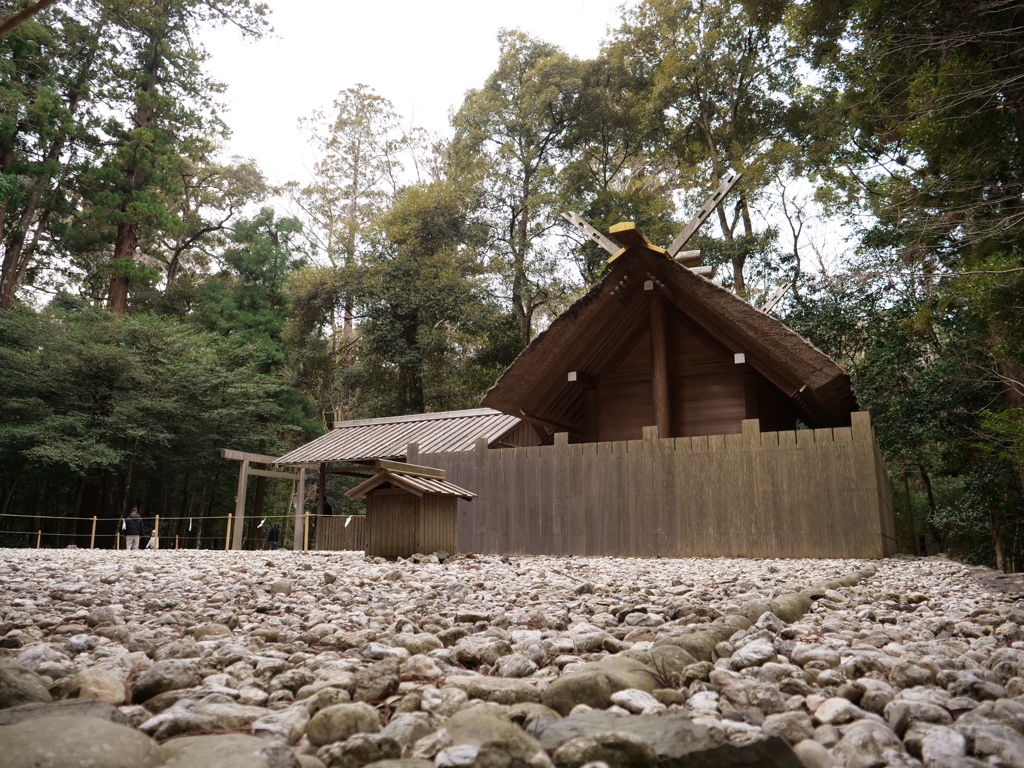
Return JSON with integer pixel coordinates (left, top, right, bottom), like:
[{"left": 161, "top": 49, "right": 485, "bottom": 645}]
[{"left": 0, "top": 550, "right": 1024, "bottom": 768}]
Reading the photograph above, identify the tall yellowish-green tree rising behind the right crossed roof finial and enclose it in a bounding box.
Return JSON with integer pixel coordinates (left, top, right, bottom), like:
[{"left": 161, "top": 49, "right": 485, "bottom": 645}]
[{"left": 609, "top": 0, "right": 800, "bottom": 297}]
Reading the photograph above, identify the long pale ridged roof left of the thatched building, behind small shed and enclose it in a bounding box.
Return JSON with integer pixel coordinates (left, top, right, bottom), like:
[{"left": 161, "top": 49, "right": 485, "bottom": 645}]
[{"left": 278, "top": 408, "right": 520, "bottom": 464}]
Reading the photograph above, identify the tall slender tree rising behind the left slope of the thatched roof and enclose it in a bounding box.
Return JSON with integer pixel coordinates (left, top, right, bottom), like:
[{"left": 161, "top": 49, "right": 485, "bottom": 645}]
[{"left": 451, "top": 30, "right": 592, "bottom": 346}]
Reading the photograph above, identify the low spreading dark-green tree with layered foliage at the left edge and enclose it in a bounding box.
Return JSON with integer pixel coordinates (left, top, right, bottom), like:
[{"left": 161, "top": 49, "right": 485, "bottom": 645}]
[{"left": 0, "top": 296, "right": 315, "bottom": 534}]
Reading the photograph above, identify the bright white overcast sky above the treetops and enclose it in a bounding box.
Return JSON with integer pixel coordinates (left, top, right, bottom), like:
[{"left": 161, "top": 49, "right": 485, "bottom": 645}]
[{"left": 198, "top": 0, "right": 622, "bottom": 183}]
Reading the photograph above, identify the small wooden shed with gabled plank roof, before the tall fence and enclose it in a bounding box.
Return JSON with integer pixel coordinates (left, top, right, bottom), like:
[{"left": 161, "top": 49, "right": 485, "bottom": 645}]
[{"left": 346, "top": 459, "right": 476, "bottom": 557}]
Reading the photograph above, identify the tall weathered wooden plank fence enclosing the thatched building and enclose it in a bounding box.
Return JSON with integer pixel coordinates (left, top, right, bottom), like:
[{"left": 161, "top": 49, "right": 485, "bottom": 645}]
[{"left": 410, "top": 412, "right": 896, "bottom": 558}]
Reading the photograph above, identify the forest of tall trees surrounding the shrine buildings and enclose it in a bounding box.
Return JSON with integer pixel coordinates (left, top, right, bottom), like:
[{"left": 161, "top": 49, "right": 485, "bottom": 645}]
[{"left": 0, "top": 0, "right": 1024, "bottom": 570}]
